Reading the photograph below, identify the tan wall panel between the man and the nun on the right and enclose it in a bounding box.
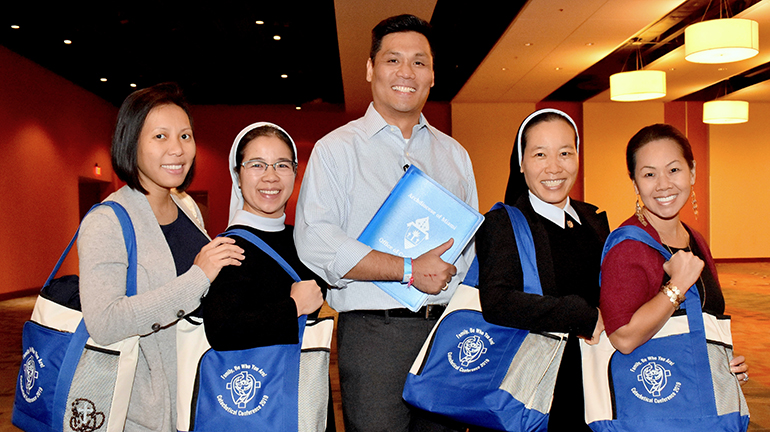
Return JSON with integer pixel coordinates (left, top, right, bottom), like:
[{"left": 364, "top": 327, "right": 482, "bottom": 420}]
[{"left": 452, "top": 103, "right": 535, "bottom": 214}]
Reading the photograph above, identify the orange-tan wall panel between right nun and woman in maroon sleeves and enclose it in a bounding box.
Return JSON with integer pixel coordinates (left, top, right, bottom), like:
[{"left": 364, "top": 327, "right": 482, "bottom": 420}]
[{"left": 581, "top": 102, "right": 663, "bottom": 229}]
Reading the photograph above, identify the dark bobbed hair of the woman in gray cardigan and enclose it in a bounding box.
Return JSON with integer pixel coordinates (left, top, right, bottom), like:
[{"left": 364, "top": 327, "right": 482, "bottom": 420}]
[{"left": 110, "top": 83, "right": 195, "bottom": 195}]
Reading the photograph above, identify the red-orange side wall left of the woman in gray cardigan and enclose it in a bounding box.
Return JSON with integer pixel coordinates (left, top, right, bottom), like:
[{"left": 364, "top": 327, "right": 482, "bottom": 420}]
[{"left": 0, "top": 46, "right": 117, "bottom": 295}]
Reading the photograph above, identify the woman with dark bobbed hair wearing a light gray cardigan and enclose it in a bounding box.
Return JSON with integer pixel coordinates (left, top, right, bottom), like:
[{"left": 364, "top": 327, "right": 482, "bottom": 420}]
[{"left": 78, "top": 84, "right": 243, "bottom": 431}]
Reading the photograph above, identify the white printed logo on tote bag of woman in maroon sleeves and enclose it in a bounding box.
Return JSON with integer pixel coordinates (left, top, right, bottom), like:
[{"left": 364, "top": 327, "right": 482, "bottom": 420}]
[{"left": 631, "top": 356, "right": 682, "bottom": 404}]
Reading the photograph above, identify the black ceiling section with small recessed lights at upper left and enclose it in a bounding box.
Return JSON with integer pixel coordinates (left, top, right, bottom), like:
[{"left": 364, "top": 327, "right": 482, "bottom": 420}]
[{"left": 0, "top": 0, "right": 344, "bottom": 105}]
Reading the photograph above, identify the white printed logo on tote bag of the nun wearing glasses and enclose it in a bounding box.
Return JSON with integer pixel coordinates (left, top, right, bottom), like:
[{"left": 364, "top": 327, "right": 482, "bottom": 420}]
[{"left": 217, "top": 364, "right": 270, "bottom": 417}]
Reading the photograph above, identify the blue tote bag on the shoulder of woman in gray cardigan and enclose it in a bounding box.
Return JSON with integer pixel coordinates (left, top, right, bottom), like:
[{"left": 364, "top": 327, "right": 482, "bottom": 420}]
[{"left": 12, "top": 201, "right": 139, "bottom": 432}]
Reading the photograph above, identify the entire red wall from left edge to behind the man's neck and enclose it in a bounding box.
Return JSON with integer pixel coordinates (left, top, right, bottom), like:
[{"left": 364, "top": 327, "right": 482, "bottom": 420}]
[{"left": 0, "top": 46, "right": 451, "bottom": 298}]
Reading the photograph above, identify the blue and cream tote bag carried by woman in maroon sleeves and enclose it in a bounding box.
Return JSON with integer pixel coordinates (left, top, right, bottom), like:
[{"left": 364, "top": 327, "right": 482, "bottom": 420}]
[{"left": 580, "top": 226, "right": 749, "bottom": 432}]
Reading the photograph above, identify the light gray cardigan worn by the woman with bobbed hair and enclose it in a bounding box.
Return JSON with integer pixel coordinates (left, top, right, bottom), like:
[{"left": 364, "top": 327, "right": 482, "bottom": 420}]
[{"left": 78, "top": 186, "right": 209, "bottom": 431}]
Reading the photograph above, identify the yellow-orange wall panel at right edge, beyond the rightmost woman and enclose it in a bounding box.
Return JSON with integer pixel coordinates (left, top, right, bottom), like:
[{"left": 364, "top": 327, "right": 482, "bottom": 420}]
[{"left": 698, "top": 102, "right": 770, "bottom": 258}]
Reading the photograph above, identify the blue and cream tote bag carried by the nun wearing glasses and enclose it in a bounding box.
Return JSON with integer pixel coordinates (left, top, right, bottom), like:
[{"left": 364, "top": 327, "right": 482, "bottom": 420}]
[{"left": 177, "top": 229, "right": 334, "bottom": 432}]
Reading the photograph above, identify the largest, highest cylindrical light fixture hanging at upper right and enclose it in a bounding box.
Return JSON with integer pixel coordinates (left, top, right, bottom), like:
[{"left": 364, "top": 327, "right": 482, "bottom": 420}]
[{"left": 684, "top": 18, "right": 759, "bottom": 64}]
